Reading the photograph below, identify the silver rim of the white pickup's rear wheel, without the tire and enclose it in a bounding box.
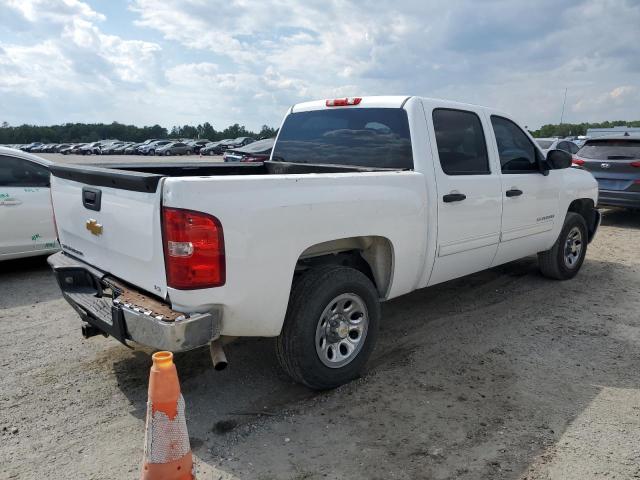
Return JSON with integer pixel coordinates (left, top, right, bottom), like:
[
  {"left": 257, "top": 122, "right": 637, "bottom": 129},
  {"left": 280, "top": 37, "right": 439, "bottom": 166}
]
[{"left": 316, "top": 293, "right": 369, "bottom": 368}]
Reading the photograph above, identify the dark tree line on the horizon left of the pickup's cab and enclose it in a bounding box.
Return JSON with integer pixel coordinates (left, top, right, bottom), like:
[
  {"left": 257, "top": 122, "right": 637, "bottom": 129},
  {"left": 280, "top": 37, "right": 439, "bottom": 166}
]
[{"left": 0, "top": 122, "right": 277, "bottom": 144}]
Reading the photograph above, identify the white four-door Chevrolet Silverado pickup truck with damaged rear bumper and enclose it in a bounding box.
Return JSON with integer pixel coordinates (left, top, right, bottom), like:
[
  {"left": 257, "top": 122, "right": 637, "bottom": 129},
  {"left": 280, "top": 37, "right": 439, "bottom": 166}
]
[{"left": 49, "top": 97, "right": 600, "bottom": 389}]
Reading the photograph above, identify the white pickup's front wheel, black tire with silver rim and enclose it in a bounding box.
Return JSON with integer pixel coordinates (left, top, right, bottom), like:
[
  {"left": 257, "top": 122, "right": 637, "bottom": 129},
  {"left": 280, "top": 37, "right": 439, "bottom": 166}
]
[{"left": 538, "top": 212, "right": 588, "bottom": 280}]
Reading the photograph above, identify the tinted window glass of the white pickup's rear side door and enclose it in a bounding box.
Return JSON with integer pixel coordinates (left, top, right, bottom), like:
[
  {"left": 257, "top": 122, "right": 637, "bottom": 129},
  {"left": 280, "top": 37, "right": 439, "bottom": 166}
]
[{"left": 433, "top": 108, "right": 491, "bottom": 175}]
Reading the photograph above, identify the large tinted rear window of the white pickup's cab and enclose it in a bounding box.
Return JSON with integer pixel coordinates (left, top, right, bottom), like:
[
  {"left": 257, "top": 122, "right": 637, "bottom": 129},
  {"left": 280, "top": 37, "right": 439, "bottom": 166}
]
[{"left": 272, "top": 108, "right": 413, "bottom": 169}]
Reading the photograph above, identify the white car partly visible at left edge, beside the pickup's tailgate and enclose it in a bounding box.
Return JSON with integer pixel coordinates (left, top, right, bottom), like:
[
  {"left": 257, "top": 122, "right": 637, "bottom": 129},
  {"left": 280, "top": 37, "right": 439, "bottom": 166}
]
[{"left": 0, "top": 147, "right": 59, "bottom": 260}]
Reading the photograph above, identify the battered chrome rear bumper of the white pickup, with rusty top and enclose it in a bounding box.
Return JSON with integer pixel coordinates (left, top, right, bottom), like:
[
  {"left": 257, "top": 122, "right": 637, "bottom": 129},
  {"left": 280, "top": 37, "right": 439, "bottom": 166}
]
[{"left": 48, "top": 252, "right": 220, "bottom": 352}]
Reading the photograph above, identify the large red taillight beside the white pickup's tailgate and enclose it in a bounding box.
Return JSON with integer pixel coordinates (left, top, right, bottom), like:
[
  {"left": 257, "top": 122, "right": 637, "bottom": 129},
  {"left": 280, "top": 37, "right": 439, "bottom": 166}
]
[{"left": 162, "top": 207, "right": 226, "bottom": 290}]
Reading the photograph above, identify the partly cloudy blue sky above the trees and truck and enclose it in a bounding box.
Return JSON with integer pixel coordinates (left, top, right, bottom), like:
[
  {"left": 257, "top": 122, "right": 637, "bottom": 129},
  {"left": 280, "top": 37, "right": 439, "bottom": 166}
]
[{"left": 0, "top": 0, "right": 640, "bottom": 129}]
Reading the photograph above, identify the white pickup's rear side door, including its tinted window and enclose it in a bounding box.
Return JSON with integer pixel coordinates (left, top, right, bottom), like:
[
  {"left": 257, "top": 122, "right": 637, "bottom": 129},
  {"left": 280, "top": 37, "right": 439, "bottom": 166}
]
[{"left": 426, "top": 108, "right": 502, "bottom": 285}]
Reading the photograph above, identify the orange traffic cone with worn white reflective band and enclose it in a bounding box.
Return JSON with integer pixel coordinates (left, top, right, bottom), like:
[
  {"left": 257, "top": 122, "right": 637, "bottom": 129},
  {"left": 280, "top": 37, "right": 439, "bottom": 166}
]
[{"left": 140, "top": 352, "right": 195, "bottom": 480}]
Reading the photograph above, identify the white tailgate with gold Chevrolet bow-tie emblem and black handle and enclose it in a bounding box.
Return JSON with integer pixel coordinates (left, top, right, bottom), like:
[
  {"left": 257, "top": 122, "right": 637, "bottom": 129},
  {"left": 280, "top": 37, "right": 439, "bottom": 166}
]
[{"left": 51, "top": 167, "right": 166, "bottom": 298}]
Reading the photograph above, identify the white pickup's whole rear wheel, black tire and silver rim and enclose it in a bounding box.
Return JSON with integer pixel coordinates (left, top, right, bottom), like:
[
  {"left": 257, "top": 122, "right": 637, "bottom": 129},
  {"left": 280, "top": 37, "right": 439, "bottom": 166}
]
[{"left": 276, "top": 265, "right": 380, "bottom": 390}]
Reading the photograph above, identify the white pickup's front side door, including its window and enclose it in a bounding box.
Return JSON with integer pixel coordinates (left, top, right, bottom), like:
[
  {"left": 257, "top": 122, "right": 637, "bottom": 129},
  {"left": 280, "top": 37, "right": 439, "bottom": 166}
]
[{"left": 490, "top": 115, "right": 564, "bottom": 265}]
